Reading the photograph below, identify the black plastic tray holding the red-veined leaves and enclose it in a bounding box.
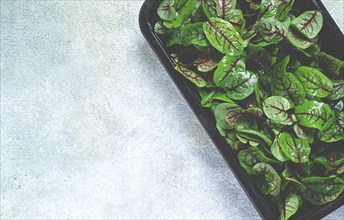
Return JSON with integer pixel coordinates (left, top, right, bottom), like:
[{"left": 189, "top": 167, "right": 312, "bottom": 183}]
[{"left": 139, "top": 0, "right": 344, "bottom": 220}]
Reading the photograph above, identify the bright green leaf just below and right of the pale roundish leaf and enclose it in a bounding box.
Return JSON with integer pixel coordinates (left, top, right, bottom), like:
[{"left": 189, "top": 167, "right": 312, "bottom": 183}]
[{"left": 278, "top": 132, "right": 311, "bottom": 164}]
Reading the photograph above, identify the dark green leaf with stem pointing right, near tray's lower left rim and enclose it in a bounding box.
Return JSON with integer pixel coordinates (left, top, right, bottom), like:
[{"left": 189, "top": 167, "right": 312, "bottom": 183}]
[{"left": 238, "top": 147, "right": 276, "bottom": 174}]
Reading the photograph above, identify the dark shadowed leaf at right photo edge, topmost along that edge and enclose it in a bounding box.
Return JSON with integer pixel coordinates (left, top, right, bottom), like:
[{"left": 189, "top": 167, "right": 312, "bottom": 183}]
[{"left": 317, "top": 52, "right": 344, "bottom": 76}]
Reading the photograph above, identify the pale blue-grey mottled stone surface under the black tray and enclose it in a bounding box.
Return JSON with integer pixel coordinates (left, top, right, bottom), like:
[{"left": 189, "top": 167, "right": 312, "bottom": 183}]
[{"left": 1, "top": 0, "right": 344, "bottom": 219}]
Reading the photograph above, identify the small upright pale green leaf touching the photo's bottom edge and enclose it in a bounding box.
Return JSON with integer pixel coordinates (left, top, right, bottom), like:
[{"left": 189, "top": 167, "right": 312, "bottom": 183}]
[{"left": 278, "top": 193, "right": 303, "bottom": 220}]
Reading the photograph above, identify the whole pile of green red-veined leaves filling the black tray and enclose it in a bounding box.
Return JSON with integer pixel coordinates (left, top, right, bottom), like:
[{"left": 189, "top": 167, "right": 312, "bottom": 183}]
[{"left": 154, "top": 0, "right": 344, "bottom": 219}]
